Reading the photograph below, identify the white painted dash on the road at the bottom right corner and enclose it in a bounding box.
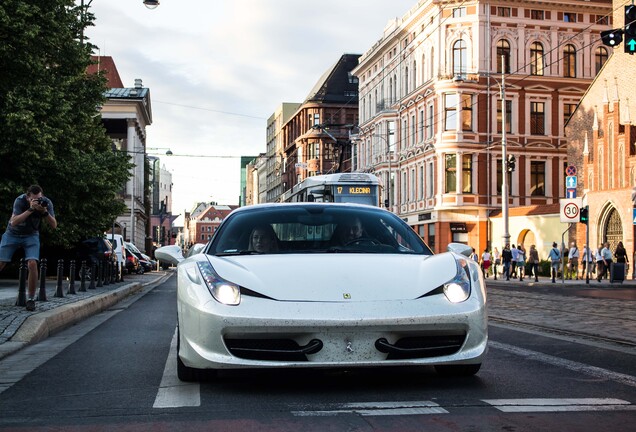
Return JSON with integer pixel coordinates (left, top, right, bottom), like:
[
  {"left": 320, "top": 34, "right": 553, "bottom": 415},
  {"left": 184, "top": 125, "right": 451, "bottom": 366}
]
[{"left": 482, "top": 398, "right": 636, "bottom": 413}]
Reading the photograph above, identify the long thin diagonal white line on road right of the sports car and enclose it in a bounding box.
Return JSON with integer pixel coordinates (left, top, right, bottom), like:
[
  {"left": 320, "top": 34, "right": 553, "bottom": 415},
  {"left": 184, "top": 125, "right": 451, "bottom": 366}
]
[{"left": 488, "top": 341, "right": 636, "bottom": 387}]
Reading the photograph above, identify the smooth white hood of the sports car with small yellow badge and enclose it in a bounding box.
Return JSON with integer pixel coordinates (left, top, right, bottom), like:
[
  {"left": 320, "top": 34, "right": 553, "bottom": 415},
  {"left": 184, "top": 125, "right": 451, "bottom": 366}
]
[{"left": 206, "top": 253, "right": 457, "bottom": 302}]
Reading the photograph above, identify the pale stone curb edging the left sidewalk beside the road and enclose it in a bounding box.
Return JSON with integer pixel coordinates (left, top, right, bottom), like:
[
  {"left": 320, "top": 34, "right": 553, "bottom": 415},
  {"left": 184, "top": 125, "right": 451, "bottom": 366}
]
[{"left": 0, "top": 273, "right": 172, "bottom": 360}]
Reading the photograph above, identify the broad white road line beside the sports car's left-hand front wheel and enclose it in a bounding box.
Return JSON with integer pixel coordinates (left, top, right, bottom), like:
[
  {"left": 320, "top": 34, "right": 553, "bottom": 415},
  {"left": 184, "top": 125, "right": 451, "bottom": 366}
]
[{"left": 152, "top": 329, "right": 201, "bottom": 408}]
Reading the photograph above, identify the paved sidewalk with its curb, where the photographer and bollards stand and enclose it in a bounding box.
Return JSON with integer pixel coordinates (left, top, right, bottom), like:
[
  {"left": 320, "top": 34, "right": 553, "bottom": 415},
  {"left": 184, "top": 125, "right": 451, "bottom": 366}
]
[{"left": 0, "top": 270, "right": 173, "bottom": 359}]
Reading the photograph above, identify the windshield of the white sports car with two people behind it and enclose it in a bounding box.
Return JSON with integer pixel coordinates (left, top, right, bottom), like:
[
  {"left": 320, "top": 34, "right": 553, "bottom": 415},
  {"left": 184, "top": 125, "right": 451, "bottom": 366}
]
[{"left": 207, "top": 204, "right": 433, "bottom": 255}]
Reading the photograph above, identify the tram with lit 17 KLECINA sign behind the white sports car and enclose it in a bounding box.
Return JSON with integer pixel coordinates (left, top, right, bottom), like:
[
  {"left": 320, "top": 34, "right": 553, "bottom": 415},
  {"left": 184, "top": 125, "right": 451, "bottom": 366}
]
[{"left": 282, "top": 173, "right": 380, "bottom": 206}]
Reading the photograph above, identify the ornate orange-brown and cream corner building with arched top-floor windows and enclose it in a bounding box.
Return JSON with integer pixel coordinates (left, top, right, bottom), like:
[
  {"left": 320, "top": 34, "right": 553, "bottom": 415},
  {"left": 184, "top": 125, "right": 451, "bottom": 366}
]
[{"left": 353, "top": 0, "right": 612, "bottom": 251}]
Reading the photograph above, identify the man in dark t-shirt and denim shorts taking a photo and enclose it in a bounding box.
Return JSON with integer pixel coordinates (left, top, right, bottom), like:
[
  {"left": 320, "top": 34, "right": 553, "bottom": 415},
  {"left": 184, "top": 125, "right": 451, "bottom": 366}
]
[{"left": 0, "top": 185, "right": 57, "bottom": 311}]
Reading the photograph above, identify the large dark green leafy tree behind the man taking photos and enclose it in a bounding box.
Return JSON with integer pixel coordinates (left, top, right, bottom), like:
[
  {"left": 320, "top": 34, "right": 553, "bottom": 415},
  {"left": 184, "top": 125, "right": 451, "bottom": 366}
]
[{"left": 0, "top": 0, "right": 130, "bottom": 248}]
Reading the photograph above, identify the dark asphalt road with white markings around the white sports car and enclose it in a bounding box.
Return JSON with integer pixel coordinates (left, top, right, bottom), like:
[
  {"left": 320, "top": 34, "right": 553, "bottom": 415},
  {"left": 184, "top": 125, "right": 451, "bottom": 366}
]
[{"left": 0, "top": 278, "right": 636, "bottom": 432}]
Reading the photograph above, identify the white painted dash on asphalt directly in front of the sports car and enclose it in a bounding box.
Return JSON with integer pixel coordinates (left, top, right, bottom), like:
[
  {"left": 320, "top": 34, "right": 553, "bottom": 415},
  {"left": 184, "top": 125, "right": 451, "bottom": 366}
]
[{"left": 292, "top": 401, "right": 448, "bottom": 417}]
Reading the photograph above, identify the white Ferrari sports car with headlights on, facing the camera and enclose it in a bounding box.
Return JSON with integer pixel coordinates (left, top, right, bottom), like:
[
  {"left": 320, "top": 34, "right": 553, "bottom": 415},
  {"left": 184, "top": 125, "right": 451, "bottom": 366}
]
[{"left": 155, "top": 203, "right": 488, "bottom": 381}]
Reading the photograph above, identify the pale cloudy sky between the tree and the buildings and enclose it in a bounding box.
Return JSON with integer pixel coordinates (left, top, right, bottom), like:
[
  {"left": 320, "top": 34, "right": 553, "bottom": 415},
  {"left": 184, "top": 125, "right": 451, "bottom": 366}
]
[{"left": 88, "top": 0, "right": 417, "bottom": 221}]
